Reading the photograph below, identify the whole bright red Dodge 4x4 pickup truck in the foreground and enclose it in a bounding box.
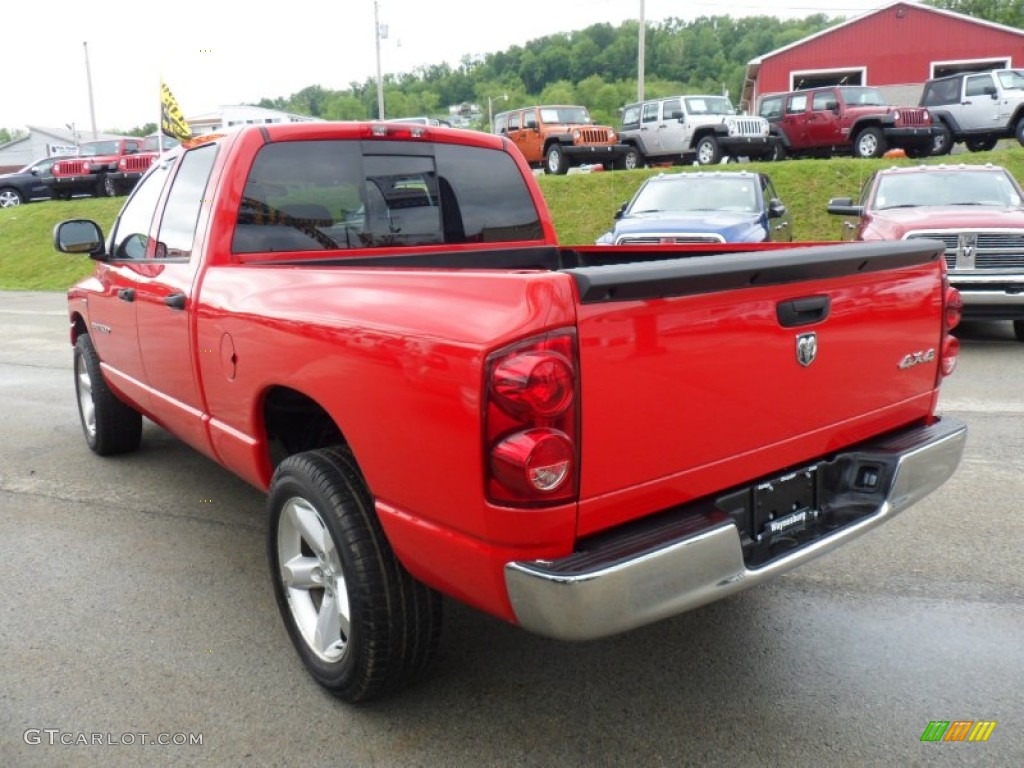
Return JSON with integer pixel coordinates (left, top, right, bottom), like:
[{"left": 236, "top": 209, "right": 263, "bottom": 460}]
[{"left": 54, "top": 123, "right": 967, "bottom": 701}]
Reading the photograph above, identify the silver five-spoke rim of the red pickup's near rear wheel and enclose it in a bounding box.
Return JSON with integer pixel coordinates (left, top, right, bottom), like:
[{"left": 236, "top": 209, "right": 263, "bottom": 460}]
[{"left": 278, "top": 497, "right": 351, "bottom": 663}]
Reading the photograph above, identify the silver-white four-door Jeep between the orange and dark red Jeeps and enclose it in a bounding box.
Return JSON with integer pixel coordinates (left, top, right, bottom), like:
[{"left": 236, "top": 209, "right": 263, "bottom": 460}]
[{"left": 618, "top": 95, "right": 775, "bottom": 169}]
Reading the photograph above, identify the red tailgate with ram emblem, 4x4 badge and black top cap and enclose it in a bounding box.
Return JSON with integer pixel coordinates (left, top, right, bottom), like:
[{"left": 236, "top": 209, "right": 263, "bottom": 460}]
[{"left": 566, "top": 241, "right": 943, "bottom": 535}]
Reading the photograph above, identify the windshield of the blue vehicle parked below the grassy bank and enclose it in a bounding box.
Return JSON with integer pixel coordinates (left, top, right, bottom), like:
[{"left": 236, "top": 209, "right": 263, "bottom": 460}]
[{"left": 629, "top": 176, "right": 758, "bottom": 215}]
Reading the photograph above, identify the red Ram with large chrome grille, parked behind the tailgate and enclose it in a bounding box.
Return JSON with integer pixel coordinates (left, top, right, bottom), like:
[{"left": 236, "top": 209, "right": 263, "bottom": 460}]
[{"left": 828, "top": 165, "right": 1024, "bottom": 341}]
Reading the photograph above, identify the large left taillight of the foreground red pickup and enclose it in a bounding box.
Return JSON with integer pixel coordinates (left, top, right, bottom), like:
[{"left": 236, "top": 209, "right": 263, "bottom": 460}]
[{"left": 484, "top": 331, "right": 579, "bottom": 506}]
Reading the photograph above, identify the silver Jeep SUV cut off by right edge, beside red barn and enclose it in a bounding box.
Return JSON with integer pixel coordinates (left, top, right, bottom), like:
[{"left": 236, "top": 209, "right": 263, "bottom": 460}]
[{"left": 921, "top": 70, "right": 1024, "bottom": 155}]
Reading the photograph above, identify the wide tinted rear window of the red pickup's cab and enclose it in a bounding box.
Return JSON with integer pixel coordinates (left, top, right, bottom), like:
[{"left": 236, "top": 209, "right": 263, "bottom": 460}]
[{"left": 232, "top": 140, "right": 544, "bottom": 253}]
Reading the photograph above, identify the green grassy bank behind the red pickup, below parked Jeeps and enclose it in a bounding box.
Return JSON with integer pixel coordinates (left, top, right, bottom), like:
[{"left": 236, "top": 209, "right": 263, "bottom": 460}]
[{"left": 0, "top": 143, "right": 1024, "bottom": 291}]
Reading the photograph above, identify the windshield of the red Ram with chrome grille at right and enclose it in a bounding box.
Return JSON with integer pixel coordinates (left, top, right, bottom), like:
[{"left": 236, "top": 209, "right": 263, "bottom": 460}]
[{"left": 874, "top": 171, "right": 1021, "bottom": 210}]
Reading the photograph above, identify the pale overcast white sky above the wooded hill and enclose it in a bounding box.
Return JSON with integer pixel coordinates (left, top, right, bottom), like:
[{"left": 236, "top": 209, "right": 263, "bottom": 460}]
[{"left": 0, "top": 0, "right": 889, "bottom": 132}]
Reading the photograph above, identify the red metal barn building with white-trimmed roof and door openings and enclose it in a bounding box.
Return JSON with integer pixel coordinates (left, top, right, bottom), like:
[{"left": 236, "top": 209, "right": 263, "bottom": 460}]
[{"left": 739, "top": 2, "right": 1024, "bottom": 112}]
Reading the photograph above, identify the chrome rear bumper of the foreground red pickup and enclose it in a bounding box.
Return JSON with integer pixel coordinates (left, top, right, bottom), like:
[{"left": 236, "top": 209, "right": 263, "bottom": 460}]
[{"left": 505, "top": 418, "right": 967, "bottom": 640}]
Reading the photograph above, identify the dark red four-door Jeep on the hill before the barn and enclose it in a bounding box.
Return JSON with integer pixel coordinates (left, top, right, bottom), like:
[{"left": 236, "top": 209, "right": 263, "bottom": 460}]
[{"left": 758, "top": 85, "right": 935, "bottom": 160}]
